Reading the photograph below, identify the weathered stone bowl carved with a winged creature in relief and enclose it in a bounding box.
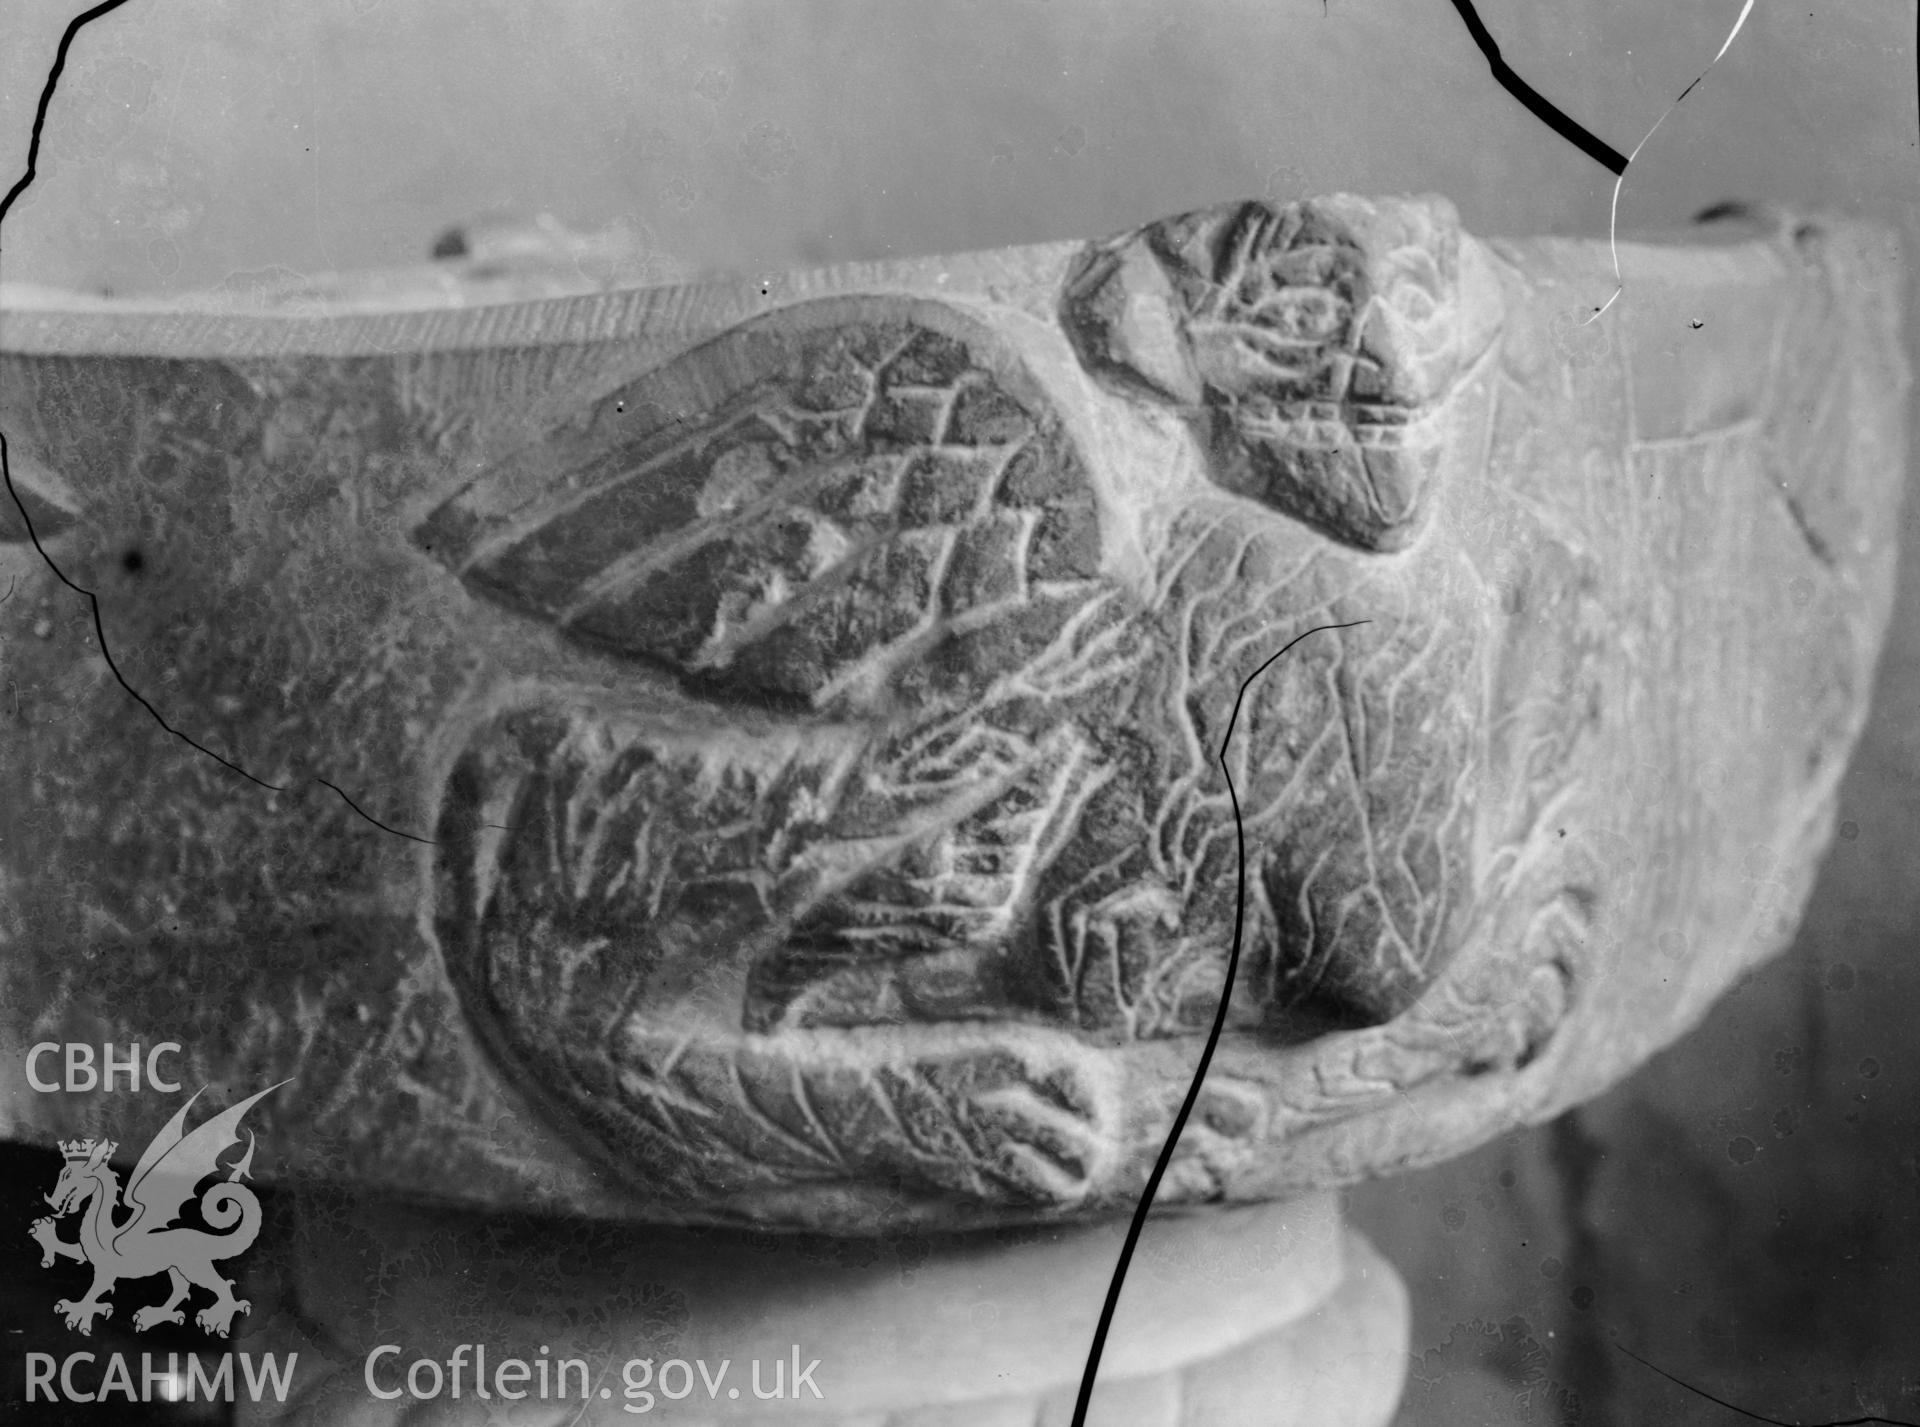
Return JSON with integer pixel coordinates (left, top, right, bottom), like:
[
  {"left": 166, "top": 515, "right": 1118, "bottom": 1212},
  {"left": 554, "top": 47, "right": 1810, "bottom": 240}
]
[{"left": 0, "top": 198, "right": 1907, "bottom": 1231}]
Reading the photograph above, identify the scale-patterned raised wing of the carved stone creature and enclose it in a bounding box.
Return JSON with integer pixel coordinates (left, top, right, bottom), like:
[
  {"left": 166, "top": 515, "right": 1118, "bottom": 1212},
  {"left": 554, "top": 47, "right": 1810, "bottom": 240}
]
[{"left": 415, "top": 296, "right": 1100, "bottom": 713}]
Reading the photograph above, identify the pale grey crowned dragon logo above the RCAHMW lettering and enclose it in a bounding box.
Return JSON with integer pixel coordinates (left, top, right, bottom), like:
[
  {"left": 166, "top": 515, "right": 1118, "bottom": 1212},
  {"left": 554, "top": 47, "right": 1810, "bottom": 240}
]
[{"left": 29, "top": 1081, "right": 286, "bottom": 1337}]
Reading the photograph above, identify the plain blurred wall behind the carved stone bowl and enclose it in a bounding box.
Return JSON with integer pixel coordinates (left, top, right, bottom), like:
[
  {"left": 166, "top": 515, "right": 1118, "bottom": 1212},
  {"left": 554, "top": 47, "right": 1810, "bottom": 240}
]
[{"left": 0, "top": 0, "right": 1920, "bottom": 1427}]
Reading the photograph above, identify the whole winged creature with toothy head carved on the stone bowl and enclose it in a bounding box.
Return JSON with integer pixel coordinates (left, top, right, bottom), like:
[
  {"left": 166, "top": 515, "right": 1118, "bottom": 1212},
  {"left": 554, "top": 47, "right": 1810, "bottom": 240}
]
[{"left": 415, "top": 194, "right": 1497, "bottom": 1200}]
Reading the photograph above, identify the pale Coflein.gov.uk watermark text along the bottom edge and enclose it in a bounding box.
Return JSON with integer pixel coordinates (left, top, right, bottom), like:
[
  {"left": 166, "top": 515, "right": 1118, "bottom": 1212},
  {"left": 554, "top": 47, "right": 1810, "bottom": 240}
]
[{"left": 365, "top": 1342, "right": 826, "bottom": 1414}]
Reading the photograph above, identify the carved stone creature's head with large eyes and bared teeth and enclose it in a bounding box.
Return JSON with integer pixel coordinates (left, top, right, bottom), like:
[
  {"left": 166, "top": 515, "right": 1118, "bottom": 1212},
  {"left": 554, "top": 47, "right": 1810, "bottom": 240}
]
[{"left": 1062, "top": 198, "right": 1471, "bottom": 549}]
